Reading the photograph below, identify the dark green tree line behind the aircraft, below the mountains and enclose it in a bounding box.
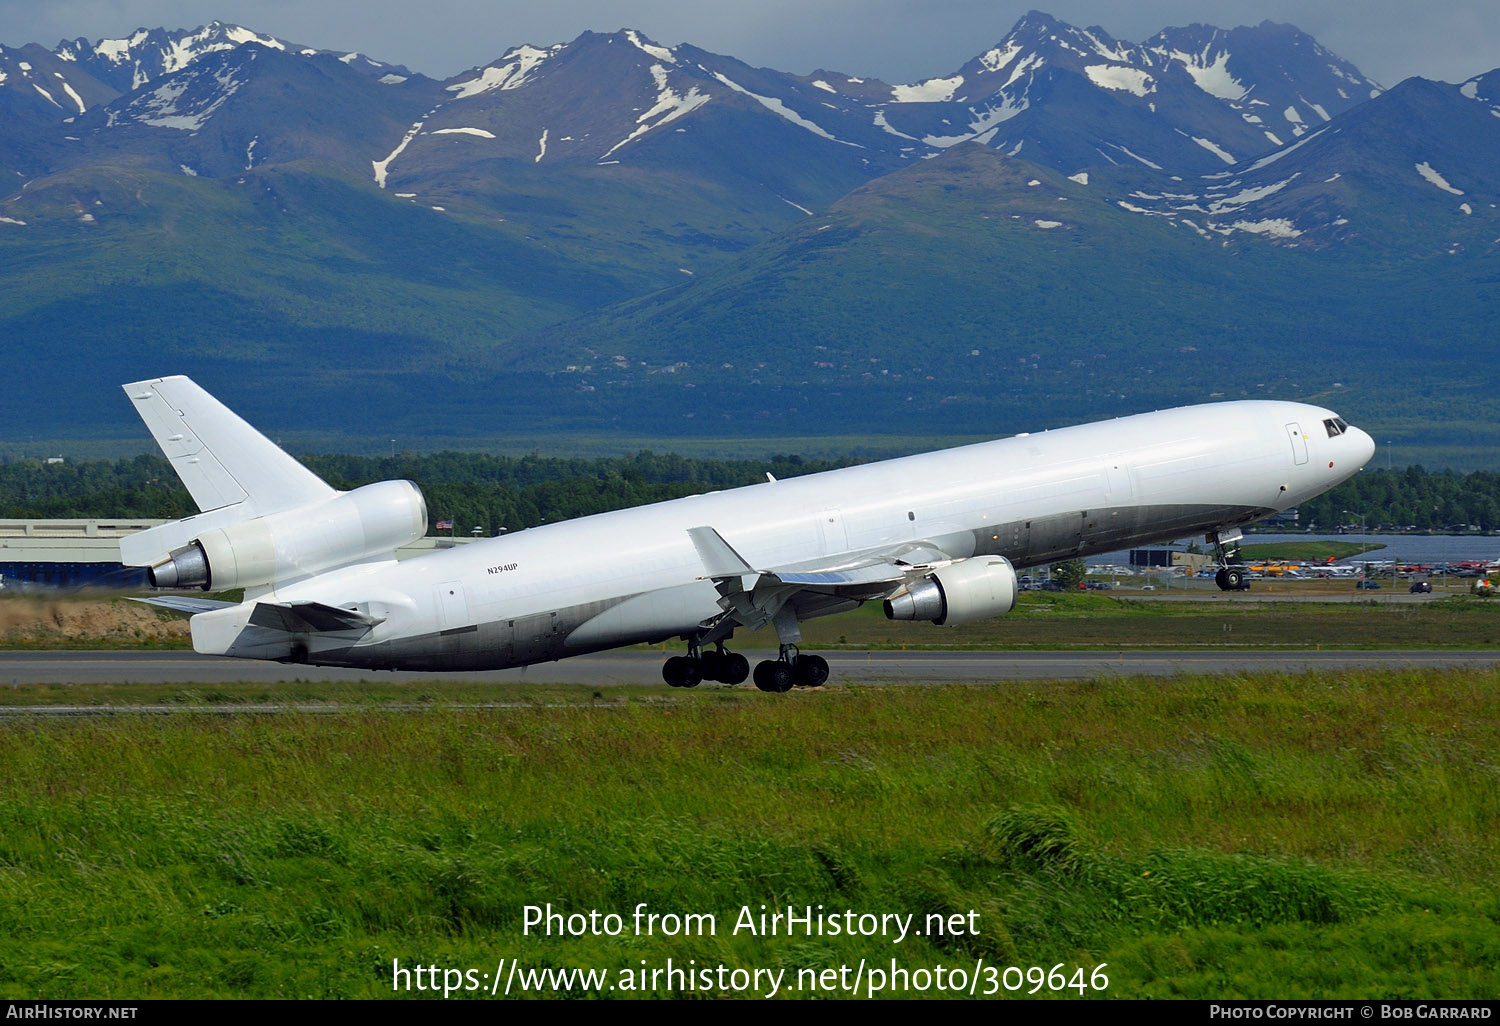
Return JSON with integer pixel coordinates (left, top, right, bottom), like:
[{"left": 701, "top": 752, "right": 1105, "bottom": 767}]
[{"left": 0, "top": 452, "right": 1500, "bottom": 536}]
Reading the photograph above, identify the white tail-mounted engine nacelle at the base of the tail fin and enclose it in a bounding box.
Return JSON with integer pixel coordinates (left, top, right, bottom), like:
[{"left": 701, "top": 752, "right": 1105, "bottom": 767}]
[{"left": 149, "top": 482, "right": 428, "bottom": 591}]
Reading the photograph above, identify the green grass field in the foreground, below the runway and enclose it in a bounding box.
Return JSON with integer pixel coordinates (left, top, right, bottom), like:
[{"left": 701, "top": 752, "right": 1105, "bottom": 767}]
[{"left": 0, "top": 672, "right": 1500, "bottom": 999}]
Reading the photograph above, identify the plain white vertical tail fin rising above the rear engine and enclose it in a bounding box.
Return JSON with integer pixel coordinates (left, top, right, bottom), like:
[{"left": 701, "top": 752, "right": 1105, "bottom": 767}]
[{"left": 120, "top": 375, "right": 338, "bottom": 566}]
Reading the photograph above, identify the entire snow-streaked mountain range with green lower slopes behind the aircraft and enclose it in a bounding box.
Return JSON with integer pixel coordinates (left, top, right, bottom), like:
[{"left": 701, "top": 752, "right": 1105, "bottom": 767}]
[{"left": 0, "top": 12, "right": 1500, "bottom": 450}]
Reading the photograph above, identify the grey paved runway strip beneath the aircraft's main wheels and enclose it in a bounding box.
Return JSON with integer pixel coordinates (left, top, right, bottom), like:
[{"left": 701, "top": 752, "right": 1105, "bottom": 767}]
[{"left": 0, "top": 648, "right": 1500, "bottom": 687}]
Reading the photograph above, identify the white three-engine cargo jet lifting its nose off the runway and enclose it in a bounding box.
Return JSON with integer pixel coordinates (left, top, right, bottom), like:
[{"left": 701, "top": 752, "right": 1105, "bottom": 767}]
[{"left": 120, "top": 377, "right": 1376, "bottom": 692}]
